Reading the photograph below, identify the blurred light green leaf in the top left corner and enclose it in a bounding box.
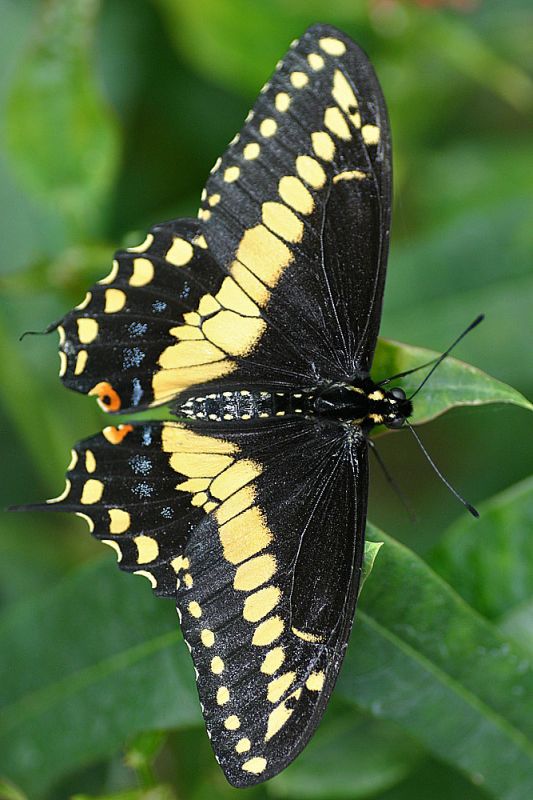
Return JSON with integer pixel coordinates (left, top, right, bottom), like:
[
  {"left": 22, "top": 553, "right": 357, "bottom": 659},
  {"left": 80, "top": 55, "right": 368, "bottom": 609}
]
[{"left": 7, "top": 0, "right": 119, "bottom": 238}]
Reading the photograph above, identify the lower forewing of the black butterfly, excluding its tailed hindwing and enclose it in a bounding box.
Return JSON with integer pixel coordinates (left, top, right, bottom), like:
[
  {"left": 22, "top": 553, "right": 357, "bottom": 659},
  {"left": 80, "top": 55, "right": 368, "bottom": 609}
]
[{"left": 172, "top": 420, "right": 367, "bottom": 786}]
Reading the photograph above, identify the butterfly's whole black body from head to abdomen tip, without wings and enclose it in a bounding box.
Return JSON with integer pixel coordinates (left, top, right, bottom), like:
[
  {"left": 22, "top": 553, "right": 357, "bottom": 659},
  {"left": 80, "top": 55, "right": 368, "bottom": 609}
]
[{"left": 175, "top": 379, "right": 412, "bottom": 428}]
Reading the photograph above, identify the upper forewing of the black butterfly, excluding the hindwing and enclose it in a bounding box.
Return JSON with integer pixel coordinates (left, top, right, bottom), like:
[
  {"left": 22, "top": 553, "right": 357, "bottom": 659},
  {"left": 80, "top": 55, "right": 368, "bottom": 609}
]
[{"left": 199, "top": 25, "right": 391, "bottom": 380}]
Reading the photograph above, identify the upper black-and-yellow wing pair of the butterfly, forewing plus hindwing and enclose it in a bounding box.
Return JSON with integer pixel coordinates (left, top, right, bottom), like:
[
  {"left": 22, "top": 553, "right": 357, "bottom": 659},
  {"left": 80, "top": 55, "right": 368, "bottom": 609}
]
[{"left": 52, "top": 25, "right": 391, "bottom": 411}]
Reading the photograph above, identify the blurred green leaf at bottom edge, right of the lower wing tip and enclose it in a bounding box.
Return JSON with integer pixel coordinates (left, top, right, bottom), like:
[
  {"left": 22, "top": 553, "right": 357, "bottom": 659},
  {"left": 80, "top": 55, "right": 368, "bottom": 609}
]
[{"left": 269, "top": 708, "right": 421, "bottom": 800}]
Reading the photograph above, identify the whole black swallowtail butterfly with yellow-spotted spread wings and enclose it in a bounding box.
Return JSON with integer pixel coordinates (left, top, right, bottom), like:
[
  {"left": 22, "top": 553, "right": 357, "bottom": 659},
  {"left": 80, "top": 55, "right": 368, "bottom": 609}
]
[{"left": 25, "top": 25, "right": 412, "bottom": 786}]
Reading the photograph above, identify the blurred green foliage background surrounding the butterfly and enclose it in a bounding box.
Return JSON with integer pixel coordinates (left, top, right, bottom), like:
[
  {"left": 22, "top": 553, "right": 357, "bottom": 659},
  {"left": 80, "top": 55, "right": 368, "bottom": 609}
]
[{"left": 0, "top": 0, "right": 533, "bottom": 800}]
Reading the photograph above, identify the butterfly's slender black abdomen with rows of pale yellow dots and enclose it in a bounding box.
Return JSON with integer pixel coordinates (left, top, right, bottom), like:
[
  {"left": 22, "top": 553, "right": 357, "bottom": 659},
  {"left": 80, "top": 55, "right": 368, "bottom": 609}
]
[{"left": 174, "top": 389, "right": 315, "bottom": 422}]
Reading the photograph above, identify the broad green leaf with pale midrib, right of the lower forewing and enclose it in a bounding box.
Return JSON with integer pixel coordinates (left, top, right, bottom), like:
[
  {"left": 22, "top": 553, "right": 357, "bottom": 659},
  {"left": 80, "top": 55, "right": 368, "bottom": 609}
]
[{"left": 337, "top": 529, "right": 533, "bottom": 800}]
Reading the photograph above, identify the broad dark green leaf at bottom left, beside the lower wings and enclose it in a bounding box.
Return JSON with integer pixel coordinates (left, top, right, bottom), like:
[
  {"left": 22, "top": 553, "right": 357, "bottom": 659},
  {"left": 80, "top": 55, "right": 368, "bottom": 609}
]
[{"left": 0, "top": 559, "right": 200, "bottom": 797}]
